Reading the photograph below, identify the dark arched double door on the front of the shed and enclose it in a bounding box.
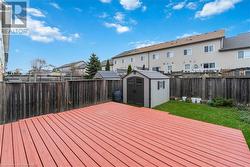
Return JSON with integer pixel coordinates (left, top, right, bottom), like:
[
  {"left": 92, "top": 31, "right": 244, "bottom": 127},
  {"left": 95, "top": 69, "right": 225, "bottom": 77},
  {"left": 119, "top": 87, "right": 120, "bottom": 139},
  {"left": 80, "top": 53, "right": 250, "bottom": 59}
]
[{"left": 127, "top": 77, "right": 144, "bottom": 106}]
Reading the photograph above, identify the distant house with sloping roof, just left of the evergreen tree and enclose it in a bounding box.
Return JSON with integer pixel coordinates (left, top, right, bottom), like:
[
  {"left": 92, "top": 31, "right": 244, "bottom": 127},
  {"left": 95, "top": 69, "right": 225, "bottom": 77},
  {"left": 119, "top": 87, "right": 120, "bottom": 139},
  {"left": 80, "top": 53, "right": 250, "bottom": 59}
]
[{"left": 54, "top": 61, "right": 87, "bottom": 76}]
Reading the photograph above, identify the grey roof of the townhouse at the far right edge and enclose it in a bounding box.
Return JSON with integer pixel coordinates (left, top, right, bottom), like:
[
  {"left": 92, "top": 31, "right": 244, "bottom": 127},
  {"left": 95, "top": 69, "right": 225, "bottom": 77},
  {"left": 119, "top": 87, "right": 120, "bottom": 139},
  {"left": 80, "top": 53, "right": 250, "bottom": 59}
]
[{"left": 220, "top": 32, "right": 250, "bottom": 51}]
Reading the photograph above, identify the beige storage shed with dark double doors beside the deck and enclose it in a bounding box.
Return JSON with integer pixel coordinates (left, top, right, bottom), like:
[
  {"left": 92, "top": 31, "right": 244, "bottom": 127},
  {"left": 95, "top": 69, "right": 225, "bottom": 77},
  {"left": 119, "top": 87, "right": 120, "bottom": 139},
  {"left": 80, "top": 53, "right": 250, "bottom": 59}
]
[{"left": 123, "top": 70, "right": 170, "bottom": 108}]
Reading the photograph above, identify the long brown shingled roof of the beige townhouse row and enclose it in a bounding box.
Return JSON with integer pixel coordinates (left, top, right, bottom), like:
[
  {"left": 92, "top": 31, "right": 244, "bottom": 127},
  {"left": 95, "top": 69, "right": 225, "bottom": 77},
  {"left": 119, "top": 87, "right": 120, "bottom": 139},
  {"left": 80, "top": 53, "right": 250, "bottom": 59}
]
[{"left": 113, "top": 30, "right": 225, "bottom": 59}]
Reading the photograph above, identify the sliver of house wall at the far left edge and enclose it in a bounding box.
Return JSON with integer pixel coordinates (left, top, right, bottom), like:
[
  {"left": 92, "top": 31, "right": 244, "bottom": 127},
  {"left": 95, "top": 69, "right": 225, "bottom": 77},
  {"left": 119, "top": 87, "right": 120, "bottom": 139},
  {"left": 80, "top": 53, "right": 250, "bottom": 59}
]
[{"left": 0, "top": 1, "right": 11, "bottom": 82}]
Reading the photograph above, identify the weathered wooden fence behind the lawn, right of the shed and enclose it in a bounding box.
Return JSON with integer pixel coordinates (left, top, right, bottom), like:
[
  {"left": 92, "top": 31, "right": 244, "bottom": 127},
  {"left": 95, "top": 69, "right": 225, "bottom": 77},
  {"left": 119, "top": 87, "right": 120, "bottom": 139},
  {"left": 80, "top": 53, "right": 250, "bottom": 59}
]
[{"left": 170, "top": 78, "right": 250, "bottom": 104}]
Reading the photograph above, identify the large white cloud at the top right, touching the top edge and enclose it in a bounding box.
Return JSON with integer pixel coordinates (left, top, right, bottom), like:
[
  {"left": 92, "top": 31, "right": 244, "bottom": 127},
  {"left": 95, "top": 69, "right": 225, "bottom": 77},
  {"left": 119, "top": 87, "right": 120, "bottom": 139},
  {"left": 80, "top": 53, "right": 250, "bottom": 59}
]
[{"left": 195, "top": 0, "right": 242, "bottom": 18}]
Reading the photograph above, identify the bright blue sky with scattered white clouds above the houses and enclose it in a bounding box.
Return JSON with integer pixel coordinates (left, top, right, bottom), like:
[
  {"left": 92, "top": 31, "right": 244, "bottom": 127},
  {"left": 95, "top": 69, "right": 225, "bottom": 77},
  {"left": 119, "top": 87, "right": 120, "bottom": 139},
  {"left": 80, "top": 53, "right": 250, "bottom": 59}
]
[{"left": 7, "top": 0, "right": 250, "bottom": 72}]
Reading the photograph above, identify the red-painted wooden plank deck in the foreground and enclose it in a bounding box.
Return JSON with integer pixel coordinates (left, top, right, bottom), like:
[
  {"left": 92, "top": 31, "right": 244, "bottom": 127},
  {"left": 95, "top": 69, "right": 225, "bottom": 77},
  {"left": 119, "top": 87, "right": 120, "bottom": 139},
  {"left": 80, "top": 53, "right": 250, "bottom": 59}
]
[{"left": 0, "top": 102, "right": 250, "bottom": 167}]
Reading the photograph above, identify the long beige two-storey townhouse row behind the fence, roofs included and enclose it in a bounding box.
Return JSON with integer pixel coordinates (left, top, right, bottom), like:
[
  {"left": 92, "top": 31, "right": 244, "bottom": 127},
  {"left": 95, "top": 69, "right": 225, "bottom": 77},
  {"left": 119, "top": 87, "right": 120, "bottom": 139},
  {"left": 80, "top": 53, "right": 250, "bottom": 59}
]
[{"left": 113, "top": 30, "right": 250, "bottom": 76}]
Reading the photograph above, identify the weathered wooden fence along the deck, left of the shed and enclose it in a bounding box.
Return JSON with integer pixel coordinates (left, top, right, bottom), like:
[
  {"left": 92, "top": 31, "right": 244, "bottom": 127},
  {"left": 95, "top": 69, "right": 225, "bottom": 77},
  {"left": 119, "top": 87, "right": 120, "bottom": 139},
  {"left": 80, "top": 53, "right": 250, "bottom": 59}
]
[{"left": 0, "top": 80, "right": 122, "bottom": 124}]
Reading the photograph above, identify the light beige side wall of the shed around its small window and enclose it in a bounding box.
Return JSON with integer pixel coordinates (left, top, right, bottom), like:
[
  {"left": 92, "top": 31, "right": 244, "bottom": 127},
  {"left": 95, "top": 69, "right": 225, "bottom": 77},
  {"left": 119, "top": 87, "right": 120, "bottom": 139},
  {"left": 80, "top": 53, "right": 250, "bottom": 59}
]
[{"left": 151, "top": 79, "right": 169, "bottom": 108}]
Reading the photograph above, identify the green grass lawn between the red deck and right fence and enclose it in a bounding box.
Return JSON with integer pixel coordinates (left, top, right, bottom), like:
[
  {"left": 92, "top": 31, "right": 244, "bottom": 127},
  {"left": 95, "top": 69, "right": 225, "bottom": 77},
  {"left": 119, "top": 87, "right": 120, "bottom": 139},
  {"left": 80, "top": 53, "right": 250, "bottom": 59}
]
[{"left": 155, "top": 101, "right": 250, "bottom": 148}]
